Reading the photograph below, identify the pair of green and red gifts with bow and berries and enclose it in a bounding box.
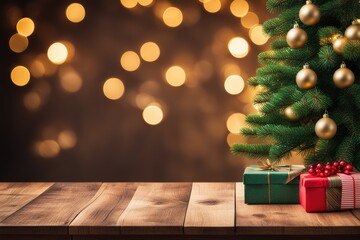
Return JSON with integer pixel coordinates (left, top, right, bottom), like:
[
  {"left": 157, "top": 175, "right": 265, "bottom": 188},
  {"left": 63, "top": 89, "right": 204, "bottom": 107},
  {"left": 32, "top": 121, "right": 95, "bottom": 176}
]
[{"left": 243, "top": 160, "right": 360, "bottom": 212}]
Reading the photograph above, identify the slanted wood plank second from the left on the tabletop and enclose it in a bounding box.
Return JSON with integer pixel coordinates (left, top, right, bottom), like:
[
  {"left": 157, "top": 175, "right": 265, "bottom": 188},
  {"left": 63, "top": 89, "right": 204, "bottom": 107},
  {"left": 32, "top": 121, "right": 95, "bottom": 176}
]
[{"left": 0, "top": 183, "right": 101, "bottom": 235}]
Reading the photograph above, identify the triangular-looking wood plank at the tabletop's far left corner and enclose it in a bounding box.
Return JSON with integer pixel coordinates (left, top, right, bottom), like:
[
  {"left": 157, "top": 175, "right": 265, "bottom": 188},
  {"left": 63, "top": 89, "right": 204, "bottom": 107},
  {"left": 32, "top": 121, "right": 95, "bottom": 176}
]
[{"left": 0, "top": 183, "right": 53, "bottom": 222}]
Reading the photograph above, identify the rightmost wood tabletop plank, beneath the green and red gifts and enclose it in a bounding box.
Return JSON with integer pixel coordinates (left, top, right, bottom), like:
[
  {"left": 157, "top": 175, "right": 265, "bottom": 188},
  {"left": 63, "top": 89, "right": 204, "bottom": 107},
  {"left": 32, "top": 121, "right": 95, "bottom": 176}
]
[{"left": 236, "top": 183, "right": 360, "bottom": 235}]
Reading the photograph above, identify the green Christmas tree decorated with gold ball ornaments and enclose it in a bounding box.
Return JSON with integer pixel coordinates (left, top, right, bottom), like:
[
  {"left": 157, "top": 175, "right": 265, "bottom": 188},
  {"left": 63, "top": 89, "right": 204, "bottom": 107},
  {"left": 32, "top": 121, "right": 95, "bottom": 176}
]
[{"left": 231, "top": 0, "right": 360, "bottom": 169}]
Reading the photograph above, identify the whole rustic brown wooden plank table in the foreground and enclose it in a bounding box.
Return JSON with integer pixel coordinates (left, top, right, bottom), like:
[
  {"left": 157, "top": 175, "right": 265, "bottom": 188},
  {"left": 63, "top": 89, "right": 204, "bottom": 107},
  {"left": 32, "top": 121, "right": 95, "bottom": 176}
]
[{"left": 0, "top": 182, "right": 360, "bottom": 240}]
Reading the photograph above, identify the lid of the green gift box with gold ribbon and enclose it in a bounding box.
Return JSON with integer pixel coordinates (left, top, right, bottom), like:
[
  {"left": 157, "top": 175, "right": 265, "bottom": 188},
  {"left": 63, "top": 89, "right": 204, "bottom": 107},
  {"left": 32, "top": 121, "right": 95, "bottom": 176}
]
[{"left": 243, "top": 165, "right": 305, "bottom": 184}]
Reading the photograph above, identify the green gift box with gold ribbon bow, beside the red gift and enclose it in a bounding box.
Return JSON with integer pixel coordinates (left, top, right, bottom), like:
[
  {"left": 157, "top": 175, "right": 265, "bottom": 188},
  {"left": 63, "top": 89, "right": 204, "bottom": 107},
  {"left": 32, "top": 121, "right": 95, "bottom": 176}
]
[{"left": 243, "top": 165, "right": 305, "bottom": 204}]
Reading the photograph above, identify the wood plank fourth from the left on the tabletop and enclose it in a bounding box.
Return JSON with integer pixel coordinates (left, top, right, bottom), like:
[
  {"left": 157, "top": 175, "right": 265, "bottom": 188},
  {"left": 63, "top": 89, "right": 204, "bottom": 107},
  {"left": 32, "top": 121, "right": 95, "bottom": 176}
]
[{"left": 119, "top": 183, "right": 191, "bottom": 235}]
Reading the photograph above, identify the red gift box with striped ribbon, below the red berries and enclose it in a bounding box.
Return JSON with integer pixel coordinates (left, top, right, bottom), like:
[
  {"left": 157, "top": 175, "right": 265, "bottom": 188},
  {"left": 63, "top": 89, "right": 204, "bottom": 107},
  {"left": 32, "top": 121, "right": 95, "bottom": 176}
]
[{"left": 299, "top": 172, "right": 360, "bottom": 212}]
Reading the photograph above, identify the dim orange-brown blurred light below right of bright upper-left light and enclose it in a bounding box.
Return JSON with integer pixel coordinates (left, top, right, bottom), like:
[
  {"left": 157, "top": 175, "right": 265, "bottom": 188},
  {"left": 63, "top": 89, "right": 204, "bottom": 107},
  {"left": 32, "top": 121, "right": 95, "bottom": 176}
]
[{"left": 59, "top": 66, "right": 82, "bottom": 93}]
